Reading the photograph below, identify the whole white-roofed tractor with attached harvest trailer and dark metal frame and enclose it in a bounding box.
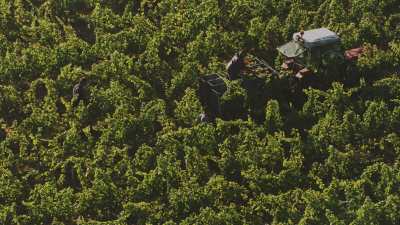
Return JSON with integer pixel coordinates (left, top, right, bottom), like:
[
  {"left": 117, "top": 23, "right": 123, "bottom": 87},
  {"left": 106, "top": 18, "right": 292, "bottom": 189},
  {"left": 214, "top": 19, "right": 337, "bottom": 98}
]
[{"left": 198, "top": 28, "right": 363, "bottom": 122}]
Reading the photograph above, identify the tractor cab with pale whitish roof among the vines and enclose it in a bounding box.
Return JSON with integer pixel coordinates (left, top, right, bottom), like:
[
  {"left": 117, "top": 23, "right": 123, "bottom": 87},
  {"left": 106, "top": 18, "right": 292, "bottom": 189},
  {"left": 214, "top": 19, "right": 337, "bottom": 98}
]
[{"left": 277, "top": 28, "right": 344, "bottom": 79}]
